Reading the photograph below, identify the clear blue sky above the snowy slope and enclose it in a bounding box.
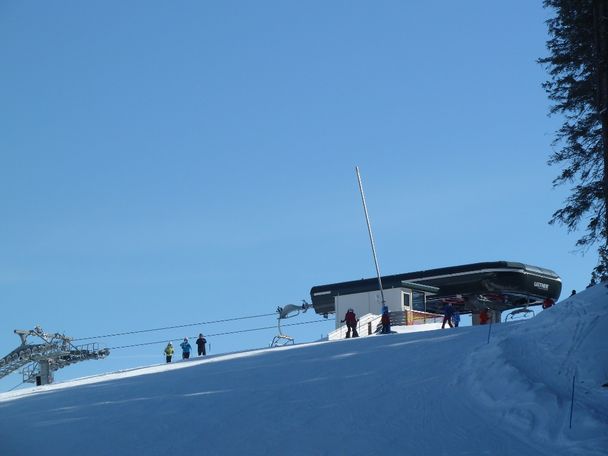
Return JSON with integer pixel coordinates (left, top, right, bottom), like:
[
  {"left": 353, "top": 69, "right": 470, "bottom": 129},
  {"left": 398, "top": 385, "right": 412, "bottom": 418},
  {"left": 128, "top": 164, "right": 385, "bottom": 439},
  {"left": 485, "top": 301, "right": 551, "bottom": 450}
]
[{"left": 0, "top": 0, "right": 595, "bottom": 390}]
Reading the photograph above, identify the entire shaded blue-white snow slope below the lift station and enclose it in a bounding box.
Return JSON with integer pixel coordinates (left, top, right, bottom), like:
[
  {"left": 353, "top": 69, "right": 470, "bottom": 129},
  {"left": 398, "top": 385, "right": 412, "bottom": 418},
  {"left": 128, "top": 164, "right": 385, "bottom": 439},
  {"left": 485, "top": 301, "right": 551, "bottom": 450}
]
[{"left": 0, "top": 285, "right": 608, "bottom": 456}]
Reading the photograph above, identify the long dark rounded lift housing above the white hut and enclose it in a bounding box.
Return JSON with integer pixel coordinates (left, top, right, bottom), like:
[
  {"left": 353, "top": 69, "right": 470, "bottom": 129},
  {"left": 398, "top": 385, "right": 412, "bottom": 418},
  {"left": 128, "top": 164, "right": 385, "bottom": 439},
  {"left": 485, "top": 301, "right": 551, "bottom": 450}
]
[{"left": 310, "top": 261, "right": 562, "bottom": 315}]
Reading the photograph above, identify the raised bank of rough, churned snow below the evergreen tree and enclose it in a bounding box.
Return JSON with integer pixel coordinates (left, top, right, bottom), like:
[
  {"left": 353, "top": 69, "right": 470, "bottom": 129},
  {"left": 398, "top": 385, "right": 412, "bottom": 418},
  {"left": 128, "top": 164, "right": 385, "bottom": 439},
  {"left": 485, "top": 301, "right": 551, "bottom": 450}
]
[{"left": 458, "top": 284, "right": 608, "bottom": 455}]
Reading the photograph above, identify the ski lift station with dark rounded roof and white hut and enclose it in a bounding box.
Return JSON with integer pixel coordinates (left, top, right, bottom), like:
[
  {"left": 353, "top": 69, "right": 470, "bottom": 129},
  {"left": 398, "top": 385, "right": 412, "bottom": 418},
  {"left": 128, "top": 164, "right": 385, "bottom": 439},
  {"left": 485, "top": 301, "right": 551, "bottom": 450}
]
[{"left": 310, "top": 261, "right": 562, "bottom": 327}]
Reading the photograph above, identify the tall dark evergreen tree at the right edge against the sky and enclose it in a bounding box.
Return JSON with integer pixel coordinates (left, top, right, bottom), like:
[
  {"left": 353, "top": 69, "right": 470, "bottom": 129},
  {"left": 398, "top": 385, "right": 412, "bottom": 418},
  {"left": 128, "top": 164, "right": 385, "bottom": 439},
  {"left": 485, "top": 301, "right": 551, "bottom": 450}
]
[{"left": 539, "top": 0, "right": 608, "bottom": 282}]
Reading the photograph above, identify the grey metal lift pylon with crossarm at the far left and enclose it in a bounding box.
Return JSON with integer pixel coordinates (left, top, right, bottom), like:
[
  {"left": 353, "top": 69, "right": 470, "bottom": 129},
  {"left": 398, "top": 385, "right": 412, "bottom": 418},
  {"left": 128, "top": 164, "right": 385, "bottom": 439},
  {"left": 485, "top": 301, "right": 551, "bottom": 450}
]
[{"left": 0, "top": 326, "right": 110, "bottom": 385}]
